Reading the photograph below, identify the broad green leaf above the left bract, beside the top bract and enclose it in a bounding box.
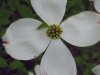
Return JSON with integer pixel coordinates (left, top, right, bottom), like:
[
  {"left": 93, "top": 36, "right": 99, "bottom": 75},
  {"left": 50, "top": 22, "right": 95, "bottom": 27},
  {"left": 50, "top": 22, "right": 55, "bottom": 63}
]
[{"left": 17, "top": 5, "right": 37, "bottom": 18}]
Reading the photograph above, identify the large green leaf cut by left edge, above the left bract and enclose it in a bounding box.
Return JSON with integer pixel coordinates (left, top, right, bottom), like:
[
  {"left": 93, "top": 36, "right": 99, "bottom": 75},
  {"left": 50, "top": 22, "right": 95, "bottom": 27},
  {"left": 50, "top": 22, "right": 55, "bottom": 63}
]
[{"left": 0, "top": 9, "right": 12, "bottom": 24}]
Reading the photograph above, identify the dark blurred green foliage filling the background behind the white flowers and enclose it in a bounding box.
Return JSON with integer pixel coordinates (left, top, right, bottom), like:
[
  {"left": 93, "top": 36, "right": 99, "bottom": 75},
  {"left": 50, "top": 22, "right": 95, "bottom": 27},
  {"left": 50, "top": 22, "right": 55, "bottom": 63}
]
[{"left": 0, "top": 0, "right": 100, "bottom": 75}]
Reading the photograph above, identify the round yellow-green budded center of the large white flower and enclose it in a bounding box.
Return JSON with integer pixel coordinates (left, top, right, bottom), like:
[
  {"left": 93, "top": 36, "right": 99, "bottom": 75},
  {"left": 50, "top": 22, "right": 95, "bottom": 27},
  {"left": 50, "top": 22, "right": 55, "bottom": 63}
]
[{"left": 46, "top": 24, "right": 63, "bottom": 39}]
